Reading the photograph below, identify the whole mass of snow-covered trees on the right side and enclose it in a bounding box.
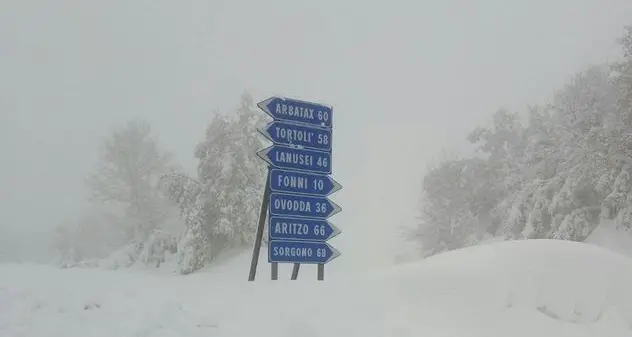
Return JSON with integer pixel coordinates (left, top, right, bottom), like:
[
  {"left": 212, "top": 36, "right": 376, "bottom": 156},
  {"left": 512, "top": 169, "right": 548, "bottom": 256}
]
[{"left": 417, "top": 33, "right": 632, "bottom": 253}]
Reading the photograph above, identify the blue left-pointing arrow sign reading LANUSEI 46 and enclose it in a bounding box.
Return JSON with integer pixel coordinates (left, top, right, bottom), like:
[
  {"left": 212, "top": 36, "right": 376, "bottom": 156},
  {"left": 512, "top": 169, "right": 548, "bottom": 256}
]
[{"left": 257, "top": 145, "right": 331, "bottom": 174}]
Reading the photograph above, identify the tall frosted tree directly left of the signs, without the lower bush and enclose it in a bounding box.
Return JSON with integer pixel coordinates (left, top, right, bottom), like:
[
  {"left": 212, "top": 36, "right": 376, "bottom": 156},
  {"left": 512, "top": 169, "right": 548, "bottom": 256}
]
[{"left": 196, "top": 94, "right": 266, "bottom": 248}]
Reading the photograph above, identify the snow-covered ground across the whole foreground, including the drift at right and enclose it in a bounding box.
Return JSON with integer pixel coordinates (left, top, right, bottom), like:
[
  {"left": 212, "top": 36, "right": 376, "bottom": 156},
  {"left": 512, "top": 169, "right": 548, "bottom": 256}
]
[{"left": 0, "top": 240, "right": 632, "bottom": 337}]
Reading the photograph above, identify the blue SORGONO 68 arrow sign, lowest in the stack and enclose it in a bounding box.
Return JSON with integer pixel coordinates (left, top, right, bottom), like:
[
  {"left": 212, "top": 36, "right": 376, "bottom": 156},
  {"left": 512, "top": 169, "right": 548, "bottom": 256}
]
[{"left": 268, "top": 240, "right": 340, "bottom": 264}]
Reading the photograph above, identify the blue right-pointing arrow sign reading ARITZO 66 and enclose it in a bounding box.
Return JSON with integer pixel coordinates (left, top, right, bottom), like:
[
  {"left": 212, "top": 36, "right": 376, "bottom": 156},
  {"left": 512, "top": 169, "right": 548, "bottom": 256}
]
[{"left": 268, "top": 216, "right": 340, "bottom": 242}]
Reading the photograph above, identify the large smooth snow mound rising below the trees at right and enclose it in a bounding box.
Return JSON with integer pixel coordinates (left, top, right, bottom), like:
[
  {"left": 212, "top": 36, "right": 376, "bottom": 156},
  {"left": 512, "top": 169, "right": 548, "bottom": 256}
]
[{"left": 354, "top": 240, "right": 632, "bottom": 336}]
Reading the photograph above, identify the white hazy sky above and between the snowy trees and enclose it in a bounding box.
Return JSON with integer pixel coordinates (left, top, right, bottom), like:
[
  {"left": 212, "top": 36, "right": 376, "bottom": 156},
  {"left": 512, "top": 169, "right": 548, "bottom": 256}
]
[{"left": 0, "top": 0, "right": 632, "bottom": 268}]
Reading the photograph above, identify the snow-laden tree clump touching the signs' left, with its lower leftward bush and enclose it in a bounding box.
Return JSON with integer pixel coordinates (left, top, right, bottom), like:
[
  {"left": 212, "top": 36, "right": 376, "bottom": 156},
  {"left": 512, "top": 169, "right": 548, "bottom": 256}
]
[{"left": 164, "top": 94, "right": 266, "bottom": 273}]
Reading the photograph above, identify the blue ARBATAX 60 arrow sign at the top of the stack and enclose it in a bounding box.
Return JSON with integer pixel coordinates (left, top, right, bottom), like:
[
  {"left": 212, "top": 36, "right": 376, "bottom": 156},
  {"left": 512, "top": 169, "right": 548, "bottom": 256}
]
[{"left": 257, "top": 97, "right": 333, "bottom": 128}]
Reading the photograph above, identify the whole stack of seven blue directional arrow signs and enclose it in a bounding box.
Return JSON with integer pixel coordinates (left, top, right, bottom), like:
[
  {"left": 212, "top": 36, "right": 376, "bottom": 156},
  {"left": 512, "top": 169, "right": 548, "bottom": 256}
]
[{"left": 253, "top": 97, "right": 342, "bottom": 279}]
